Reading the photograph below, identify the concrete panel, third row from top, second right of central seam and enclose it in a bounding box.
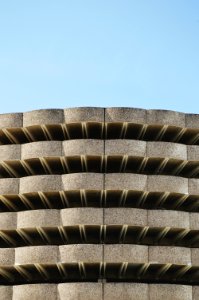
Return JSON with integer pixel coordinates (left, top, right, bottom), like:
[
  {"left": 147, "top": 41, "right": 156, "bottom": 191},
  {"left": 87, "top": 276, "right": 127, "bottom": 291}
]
[{"left": 147, "top": 175, "right": 188, "bottom": 194}]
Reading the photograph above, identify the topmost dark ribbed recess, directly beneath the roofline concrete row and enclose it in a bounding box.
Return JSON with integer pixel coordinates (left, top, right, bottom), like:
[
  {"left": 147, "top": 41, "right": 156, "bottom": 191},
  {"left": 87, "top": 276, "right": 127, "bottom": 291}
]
[{"left": 0, "top": 122, "right": 199, "bottom": 145}]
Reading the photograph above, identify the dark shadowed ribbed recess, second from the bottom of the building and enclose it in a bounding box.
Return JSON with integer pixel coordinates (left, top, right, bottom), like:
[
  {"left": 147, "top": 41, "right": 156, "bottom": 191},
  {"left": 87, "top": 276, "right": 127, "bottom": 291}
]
[{"left": 0, "top": 224, "right": 199, "bottom": 248}]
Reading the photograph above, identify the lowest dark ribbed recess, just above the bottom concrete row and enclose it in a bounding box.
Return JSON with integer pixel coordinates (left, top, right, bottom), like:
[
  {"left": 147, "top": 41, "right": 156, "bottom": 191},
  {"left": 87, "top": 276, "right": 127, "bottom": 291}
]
[{"left": 0, "top": 262, "right": 199, "bottom": 285}]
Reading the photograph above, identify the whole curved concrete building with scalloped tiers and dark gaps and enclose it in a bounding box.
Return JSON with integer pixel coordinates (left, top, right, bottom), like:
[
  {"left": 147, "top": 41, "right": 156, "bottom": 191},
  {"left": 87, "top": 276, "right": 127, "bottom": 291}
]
[{"left": 0, "top": 108, "right": 199, "bottom": 300}]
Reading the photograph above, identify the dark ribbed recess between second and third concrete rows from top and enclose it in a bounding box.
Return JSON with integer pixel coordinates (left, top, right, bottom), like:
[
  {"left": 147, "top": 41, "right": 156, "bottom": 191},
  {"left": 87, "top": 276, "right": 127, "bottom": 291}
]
[{"left": 0, "top": 155, "right": 199, "bottom": 178}]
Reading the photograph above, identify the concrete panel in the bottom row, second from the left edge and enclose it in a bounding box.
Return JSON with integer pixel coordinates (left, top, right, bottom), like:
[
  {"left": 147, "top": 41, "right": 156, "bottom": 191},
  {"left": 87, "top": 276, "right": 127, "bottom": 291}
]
[{"left": 12, "top": 284, "right": 57, "bottom": 300}]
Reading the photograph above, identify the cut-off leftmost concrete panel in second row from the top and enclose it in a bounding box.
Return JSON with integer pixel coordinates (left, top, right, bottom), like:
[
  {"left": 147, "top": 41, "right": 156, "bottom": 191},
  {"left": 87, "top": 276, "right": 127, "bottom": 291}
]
[{"left": 0, "top": 145, "right": 21, "bottom": 160}]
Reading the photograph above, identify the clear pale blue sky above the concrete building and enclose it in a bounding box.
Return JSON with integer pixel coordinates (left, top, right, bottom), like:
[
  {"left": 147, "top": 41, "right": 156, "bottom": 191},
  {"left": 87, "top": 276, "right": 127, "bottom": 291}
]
[{"left": 0, "top": 0, "right": 199, "bottom": 113}]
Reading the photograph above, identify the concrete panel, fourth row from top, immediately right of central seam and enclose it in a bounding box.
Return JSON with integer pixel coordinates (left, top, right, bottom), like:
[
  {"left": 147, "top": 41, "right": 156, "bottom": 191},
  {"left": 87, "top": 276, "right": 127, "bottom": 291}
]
[{"left": 104, "top": 208, "right": 147, "bottom": 226}]
